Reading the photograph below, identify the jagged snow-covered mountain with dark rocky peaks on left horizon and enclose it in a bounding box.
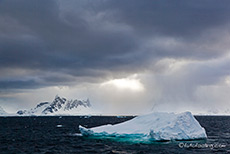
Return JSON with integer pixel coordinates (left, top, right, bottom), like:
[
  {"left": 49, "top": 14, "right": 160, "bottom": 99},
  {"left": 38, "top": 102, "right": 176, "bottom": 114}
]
[{"left": 17, "top": 96, "right": 95, "bottom": 116}]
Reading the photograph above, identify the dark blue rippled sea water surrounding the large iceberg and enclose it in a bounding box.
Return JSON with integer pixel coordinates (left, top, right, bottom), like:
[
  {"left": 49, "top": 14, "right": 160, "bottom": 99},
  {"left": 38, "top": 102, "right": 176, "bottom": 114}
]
[{"left": 0, "top": 116, "right": 230, "bottom": 154}]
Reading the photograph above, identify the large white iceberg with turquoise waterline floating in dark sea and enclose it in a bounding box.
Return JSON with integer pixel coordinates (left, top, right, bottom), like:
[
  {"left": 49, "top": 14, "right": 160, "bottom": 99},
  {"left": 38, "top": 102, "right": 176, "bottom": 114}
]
[{"left": 79, "top": 112, "right": 207, "bottom": 141}]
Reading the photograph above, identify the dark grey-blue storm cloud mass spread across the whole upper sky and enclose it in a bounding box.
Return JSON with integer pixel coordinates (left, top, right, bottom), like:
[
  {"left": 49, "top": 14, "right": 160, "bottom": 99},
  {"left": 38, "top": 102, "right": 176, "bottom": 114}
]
[{"left": 0, "top": 0, "right": 230, "bottom": 89}]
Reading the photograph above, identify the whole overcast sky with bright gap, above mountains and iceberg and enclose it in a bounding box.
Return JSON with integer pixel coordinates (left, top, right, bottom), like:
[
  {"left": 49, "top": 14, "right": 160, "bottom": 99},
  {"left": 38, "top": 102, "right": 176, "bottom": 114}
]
[{"left": 0, "top": 0, "right": 230, "bottom": 114}]
